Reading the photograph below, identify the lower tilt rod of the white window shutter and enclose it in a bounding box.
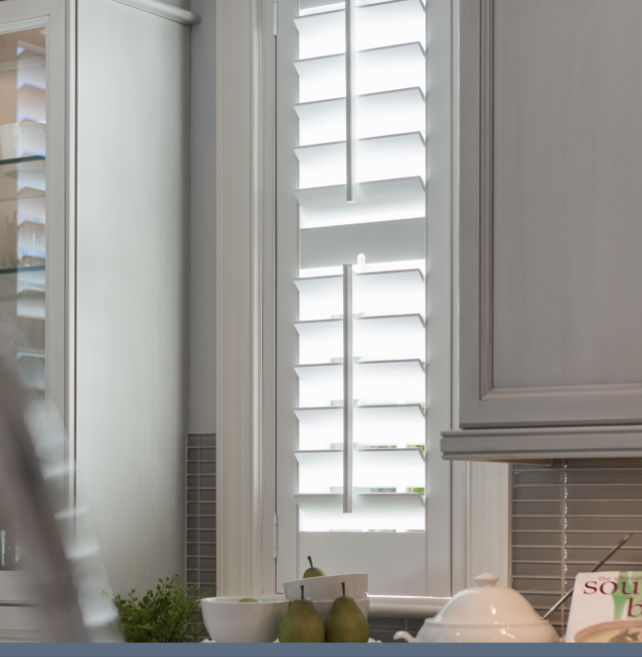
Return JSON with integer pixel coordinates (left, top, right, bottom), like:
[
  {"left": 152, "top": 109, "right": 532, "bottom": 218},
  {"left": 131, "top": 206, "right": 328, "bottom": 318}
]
[{"left": 343, "top": 265, "right": 354, "bottom": 513}]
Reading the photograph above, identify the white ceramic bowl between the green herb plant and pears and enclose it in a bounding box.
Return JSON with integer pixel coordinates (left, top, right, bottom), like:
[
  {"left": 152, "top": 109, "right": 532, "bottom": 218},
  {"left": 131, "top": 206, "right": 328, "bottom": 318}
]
[{"left": 201, "top": 596, "right": 290, "bottom": 643}]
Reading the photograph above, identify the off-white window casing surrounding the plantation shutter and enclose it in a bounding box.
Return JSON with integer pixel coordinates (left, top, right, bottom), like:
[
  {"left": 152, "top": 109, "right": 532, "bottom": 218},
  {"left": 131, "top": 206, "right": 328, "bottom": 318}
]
[{"left": 214, "top": 0, "right": 510, "bottom": 615}]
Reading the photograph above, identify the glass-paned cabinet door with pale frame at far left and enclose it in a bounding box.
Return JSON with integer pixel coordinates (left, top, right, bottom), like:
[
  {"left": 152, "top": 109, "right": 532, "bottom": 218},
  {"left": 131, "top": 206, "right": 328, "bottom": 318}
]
[{"left": 0, "top": 0, "right": 70, "bottom": 641}]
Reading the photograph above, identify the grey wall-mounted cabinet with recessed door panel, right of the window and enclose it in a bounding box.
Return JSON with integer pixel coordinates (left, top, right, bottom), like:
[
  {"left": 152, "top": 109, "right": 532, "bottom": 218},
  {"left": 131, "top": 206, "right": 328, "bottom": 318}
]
[{"left": 442, "top": 0, "right": 642, "bottom": 459}]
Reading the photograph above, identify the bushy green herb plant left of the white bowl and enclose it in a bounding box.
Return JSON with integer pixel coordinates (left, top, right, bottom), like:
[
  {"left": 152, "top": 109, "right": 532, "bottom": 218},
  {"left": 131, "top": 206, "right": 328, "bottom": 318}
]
[{"left": 114, "top": 575, "right": 209, "bottom": 643}]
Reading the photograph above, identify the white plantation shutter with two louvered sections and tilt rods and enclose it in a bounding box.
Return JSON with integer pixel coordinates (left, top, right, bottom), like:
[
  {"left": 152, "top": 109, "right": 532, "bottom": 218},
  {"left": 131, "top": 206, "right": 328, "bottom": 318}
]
[{"left": 277, "top": 0, "right": 438, "bottom": 595}]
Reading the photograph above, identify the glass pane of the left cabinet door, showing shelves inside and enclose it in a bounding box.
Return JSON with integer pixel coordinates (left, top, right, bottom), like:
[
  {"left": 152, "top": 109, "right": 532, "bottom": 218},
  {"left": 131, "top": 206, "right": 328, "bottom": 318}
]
[{"left": 0, "top": 27, "right": 47, "bottom": 571}]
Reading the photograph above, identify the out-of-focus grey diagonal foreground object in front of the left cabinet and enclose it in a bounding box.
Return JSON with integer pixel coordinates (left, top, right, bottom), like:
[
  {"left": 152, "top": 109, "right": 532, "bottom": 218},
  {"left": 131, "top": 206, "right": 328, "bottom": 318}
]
[{"left": 0, "top": 354, "right": 119, "bottom": 642}]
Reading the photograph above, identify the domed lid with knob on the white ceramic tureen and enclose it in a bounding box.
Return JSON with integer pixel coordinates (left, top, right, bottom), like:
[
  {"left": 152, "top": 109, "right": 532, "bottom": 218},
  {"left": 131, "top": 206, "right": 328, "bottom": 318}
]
[{"left": 434, "top": 573, "right": 542, "bottom": 625}]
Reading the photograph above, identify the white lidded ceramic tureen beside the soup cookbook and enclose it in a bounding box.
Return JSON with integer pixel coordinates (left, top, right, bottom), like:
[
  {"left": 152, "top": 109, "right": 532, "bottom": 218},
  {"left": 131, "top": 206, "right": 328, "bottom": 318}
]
[{"left": 394, "top": 573, "right": 560, "bottom": 643}]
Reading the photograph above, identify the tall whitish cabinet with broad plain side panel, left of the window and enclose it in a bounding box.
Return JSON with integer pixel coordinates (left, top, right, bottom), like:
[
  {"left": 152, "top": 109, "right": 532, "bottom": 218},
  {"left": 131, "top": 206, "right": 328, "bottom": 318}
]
[{"left": 0, "top": 0, "right": 197, "bottom": 593}]
